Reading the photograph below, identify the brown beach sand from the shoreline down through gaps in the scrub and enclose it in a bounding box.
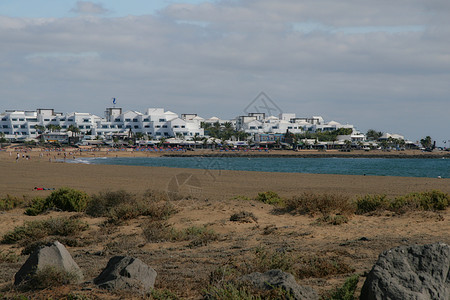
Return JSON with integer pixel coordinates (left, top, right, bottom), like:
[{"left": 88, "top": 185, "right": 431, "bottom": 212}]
[{"left": 0, "top": 152, "right": 450, "bottom": 299}]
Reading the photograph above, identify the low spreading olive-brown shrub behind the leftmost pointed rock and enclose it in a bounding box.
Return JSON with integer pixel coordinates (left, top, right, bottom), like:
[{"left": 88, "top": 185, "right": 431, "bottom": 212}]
[{"left": 1, "top": 217, "right": 88, "bottom": 244}]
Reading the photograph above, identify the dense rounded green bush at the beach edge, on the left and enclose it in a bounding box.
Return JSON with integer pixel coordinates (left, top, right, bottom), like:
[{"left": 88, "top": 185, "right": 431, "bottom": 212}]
[{"left": 46, "top": 187, "right": 89, "bottom": 212}]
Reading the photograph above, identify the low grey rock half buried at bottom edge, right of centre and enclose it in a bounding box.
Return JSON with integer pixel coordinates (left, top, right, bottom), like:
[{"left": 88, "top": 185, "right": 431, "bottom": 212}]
[{"left": 241, "top": 270, "right": 319, "bottom": 300}]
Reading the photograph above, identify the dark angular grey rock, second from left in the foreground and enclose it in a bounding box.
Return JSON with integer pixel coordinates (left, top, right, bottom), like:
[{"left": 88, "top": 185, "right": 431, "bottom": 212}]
[{"left": 94, "top": 256, "right": 157, "bottom": 292}]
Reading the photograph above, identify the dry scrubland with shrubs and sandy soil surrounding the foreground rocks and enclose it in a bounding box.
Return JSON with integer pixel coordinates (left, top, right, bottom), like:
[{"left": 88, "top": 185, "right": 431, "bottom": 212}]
[{"left": 0, "top": 188, "right": 450, "bottom": 299}]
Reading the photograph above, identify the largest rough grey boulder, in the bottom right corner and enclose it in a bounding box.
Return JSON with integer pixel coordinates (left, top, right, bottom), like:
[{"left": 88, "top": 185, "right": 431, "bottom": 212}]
[{"left": 361, "top": 243, "right": 450, "bottom": 300}]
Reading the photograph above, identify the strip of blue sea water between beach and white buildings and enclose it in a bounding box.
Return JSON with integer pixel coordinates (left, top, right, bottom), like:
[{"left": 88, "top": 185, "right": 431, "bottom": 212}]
[{"left": 72, "top": 157, "right": 450, "bottom": 178}]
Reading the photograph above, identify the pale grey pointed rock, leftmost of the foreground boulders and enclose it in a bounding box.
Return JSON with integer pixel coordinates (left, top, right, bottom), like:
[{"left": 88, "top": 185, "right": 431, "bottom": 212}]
[{"left": 14, "top": 241, "right": 83, "bottom": 285}]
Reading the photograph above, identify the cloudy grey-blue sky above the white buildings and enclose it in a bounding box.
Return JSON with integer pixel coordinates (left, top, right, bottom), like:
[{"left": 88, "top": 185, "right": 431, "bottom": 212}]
[{"left": 0, "top": 0, "right": 450, "bottom": 147}]
